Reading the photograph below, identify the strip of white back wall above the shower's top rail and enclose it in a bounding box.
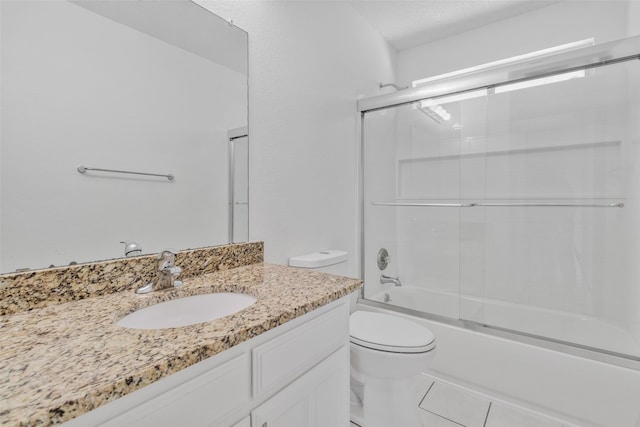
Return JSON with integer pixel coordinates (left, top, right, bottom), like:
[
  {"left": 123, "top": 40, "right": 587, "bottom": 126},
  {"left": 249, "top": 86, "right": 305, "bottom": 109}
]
[{"left": 398, "top": 0, "right": 640, "bottom": 85}]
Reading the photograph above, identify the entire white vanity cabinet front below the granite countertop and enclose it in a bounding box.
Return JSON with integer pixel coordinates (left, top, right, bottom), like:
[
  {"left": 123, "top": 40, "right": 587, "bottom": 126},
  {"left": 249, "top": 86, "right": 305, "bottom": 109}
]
[{"left": 66, "top": 297, "right": 349, "bottom": 427}]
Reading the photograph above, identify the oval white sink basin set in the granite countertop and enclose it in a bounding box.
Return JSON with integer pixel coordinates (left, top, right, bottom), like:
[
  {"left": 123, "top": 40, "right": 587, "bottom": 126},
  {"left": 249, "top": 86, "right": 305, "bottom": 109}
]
[{"left": 118, "top": 292, "right": 256, "bottom": 329}]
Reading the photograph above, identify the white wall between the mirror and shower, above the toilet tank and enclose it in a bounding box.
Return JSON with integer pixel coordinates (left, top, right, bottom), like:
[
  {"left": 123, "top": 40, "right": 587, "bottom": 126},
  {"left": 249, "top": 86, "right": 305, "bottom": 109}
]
[{"left": 199, "top": 0, "right": 395, "bottom": 275}]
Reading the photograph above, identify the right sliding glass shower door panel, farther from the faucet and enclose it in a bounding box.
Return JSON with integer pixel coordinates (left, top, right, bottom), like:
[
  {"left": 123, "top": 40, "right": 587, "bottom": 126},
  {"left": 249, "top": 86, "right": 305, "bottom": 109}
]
[{"left": 476, "top": 61, "right": 640, "bottom": 357}]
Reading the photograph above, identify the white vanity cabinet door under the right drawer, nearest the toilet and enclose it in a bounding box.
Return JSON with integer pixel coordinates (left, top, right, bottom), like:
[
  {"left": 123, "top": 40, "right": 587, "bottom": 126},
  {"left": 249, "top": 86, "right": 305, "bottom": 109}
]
[{"left": 251, "top": 345, "right": 349, "bottom": 427}]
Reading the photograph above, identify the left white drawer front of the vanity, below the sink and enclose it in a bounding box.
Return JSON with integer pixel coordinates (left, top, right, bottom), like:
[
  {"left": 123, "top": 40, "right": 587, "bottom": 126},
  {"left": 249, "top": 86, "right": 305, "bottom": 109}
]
[{"left": 103, "top": 354, "right": 251, "bottom": 427}]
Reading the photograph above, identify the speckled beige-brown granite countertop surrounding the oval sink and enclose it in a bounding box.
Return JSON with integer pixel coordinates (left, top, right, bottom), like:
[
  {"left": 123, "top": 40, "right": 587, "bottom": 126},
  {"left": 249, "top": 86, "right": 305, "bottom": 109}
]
[{"left": 0, "top": 263, "right": 361, "bottom": 425}]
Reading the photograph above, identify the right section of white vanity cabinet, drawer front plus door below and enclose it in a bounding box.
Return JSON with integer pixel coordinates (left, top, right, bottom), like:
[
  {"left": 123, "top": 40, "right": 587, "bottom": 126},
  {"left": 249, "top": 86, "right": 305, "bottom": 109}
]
[{"left": 251, "top": 300, "right": 349, "bottom": 427}]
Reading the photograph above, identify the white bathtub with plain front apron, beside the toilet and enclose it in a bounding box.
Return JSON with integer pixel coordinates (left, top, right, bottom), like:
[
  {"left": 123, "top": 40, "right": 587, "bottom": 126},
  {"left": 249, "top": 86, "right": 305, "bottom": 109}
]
[{"left": 357, "top": 286, "right": 640, "bottom": 427}]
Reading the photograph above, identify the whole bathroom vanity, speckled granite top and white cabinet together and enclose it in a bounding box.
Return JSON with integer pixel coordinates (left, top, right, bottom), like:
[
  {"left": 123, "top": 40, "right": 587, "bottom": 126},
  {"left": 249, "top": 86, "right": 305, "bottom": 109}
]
[{"left": 0, "top": 245, "right": 360, "bottom": 427}]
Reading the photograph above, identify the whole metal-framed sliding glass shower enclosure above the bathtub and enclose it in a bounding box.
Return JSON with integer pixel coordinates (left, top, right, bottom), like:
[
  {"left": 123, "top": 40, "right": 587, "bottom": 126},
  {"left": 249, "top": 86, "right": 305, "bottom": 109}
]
[{"left": 359, "top": 38, "right": 640, "bottom": 365}]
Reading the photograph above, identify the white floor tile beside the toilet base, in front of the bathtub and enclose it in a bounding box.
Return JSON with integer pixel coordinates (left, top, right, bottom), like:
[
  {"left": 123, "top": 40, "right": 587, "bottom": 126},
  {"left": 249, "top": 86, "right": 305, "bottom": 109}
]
[{"left": 420, "top": 382, "right": 490, "bottom": 427}]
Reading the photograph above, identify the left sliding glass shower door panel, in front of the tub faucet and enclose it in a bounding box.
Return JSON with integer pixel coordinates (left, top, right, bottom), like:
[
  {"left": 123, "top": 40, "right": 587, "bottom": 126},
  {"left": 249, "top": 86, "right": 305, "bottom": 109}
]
[{"left": 363, "top": 93, "right": 486, "bottom": 319}]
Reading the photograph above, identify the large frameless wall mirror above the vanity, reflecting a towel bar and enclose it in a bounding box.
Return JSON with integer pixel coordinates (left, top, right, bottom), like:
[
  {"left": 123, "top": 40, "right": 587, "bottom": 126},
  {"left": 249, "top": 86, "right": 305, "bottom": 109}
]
[{"left": 0, "top": 0, "right": 248, "bottom": 273}]
